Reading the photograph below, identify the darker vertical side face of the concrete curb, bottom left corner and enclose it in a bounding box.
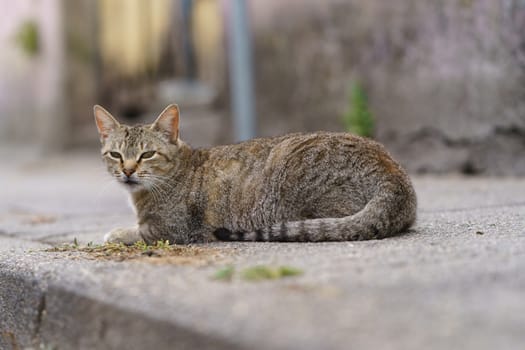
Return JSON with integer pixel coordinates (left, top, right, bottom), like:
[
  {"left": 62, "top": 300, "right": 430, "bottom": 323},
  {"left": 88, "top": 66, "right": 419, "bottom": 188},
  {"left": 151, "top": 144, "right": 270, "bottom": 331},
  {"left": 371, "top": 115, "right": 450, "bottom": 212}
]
[{"left": 0, "top": 264, "right": 245, "bottom": 350}]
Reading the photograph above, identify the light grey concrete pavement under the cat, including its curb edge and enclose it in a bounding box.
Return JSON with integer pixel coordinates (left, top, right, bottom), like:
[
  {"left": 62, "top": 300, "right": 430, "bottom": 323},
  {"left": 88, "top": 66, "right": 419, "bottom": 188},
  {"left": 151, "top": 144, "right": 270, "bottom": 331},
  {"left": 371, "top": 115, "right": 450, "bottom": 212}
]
[{"left": 0, "top": 150, "right": 525, "bottom": 350}]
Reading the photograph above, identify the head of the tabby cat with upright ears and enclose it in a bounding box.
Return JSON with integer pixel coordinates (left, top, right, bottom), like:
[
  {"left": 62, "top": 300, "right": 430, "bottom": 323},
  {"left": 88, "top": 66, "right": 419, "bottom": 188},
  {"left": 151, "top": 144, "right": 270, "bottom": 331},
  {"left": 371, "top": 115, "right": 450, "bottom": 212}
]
[{"left": 93, "top": 105, "right": 183, "bottom": 191}]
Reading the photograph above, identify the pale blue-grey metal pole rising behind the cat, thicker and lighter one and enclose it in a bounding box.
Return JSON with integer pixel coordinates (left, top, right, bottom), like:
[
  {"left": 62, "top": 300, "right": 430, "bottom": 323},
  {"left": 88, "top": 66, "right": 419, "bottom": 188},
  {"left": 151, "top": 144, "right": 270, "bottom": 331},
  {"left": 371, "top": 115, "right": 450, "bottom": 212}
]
[{"left": 229, "top": 0, "right": 255, "bottom": 141}]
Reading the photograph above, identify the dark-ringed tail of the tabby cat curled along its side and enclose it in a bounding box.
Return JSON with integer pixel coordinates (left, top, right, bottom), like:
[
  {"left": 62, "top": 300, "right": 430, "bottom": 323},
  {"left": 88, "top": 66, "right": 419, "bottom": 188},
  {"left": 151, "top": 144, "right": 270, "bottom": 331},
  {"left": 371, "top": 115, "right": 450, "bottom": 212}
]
[{"left": 215, "top": 183, "right": 416, "bottom": 242}]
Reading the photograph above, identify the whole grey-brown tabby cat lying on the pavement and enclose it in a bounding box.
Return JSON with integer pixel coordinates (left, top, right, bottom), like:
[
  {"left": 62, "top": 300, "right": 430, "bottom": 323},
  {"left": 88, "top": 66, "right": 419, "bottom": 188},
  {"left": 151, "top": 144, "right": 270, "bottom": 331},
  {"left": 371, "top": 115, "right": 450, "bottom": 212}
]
[{"left": 94, "top": 105, "right": 416, "bottom": 244}]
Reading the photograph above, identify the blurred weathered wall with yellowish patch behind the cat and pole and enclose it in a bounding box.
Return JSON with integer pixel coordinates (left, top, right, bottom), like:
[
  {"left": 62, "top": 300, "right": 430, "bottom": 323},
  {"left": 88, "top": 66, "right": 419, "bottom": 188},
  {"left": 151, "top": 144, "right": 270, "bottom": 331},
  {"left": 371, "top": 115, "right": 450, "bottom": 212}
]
[{"left": 0, "top": 0, "right": 525, "bottom": 175}]
